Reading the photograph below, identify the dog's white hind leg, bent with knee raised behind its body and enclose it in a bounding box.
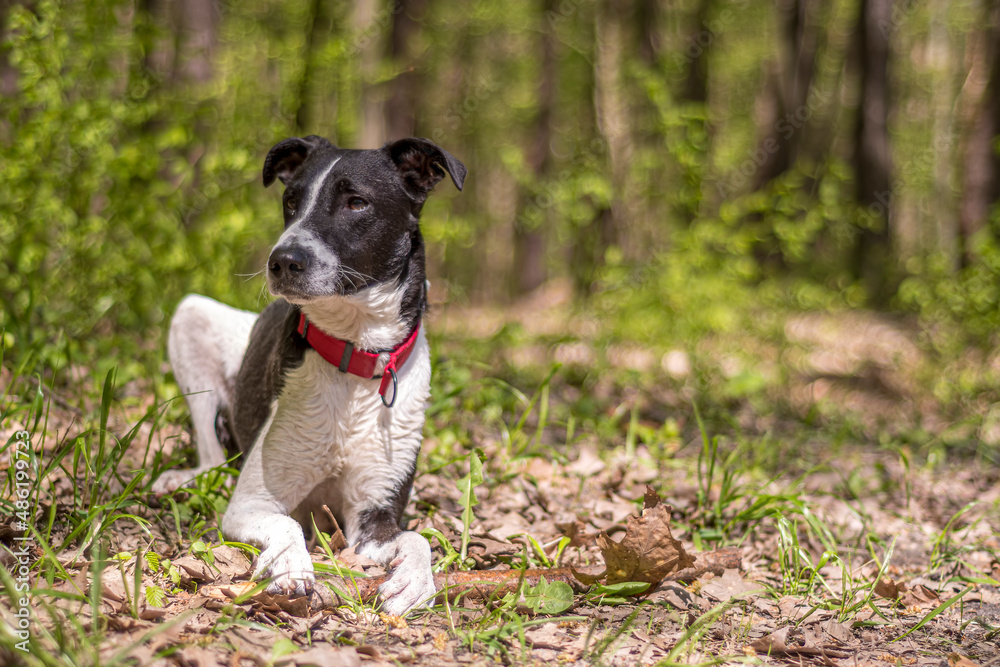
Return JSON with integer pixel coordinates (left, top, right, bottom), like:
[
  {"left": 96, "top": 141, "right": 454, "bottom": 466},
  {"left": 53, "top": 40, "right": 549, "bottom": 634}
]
[{"left": 153, "top": 294, "right": 257, "bottom": 495}]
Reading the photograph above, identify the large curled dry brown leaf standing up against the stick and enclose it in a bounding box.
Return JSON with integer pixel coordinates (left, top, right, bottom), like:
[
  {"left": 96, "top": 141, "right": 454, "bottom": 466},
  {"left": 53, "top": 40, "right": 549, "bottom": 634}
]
[{"left": 597, "top": 504, "right": 694, "bottom": 584}]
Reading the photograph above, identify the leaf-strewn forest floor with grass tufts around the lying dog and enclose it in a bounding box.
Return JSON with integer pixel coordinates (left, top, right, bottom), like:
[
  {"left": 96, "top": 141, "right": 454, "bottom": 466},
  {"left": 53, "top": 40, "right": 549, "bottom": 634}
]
[{"left": 0, "top": 292, "right": 1000, "bottom": 667}]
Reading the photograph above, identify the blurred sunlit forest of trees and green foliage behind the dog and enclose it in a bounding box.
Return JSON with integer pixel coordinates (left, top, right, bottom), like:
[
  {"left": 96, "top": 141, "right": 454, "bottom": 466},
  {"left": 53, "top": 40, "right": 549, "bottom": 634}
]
[{"left": 0, "top": 0, "right": 1000, "bottom": 434}]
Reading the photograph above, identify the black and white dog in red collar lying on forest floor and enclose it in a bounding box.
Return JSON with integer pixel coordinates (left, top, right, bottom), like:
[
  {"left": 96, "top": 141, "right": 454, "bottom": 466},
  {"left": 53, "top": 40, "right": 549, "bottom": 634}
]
[{"left": 153, "top": 136, "right": 466, "bottom": 614}]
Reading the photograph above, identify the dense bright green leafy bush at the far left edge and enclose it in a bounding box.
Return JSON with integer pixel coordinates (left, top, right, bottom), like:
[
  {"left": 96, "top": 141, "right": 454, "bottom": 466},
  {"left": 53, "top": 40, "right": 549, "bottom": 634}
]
[{"left": 0, "top": 2, "right": 188, "bottom": 362}]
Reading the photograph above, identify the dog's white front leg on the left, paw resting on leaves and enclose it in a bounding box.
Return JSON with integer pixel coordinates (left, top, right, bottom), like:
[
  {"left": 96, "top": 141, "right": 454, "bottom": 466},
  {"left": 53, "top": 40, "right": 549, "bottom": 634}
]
[{"left": 222, "top": 402, "right": 316, "bottom": 595}]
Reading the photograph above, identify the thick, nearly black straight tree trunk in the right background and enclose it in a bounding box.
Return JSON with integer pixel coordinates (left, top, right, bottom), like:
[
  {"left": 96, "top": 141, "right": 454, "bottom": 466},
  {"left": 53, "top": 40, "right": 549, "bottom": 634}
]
[{"left": 853, "top": 0, "right": 893, "bottom": 305}]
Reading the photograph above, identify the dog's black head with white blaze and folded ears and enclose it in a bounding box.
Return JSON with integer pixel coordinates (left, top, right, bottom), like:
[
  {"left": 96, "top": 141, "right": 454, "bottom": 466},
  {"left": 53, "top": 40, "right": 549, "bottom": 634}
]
[{"left": 264, "top": 136, "right": 466, "bottom": 304}]
